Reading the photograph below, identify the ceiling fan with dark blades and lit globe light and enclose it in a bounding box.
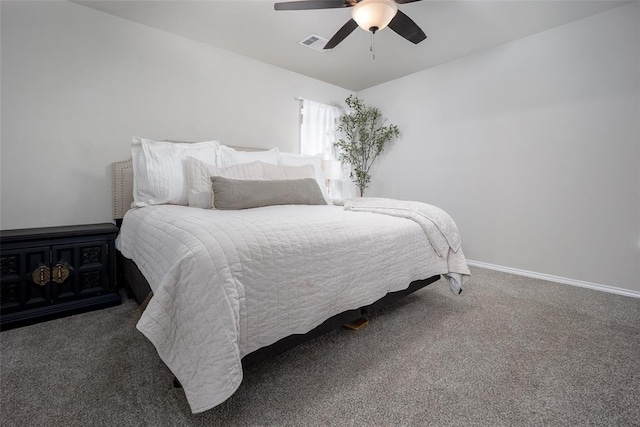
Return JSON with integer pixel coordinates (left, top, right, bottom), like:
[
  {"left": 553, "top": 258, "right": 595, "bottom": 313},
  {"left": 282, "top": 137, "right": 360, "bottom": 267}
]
[{"left": 274, "top": 0, "right": 427, "bottom": 49}]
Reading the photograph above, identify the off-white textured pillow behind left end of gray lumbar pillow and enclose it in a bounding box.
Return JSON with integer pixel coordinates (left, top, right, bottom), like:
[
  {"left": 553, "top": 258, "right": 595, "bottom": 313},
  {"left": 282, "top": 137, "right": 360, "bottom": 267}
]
[{"left": 187, "top": 157, "right": 264, "bottom": 209}]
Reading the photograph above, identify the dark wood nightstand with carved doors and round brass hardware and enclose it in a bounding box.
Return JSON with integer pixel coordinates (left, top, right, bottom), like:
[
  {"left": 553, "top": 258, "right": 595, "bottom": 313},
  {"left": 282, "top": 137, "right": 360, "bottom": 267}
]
[{"left": 0, "top": 223, "right": 122, "bottom": 330}]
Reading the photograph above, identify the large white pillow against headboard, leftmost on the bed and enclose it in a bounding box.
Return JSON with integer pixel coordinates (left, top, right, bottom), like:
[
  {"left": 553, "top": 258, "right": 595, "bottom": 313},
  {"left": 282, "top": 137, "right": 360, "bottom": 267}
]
[{"left": 131, "top": 137, "right": 219, "bottom": 207}]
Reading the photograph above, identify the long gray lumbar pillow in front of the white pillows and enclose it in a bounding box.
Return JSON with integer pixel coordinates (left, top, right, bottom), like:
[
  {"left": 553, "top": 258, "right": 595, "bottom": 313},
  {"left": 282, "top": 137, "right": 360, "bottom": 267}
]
[{"left": 211, "top": 176, "right": 327, "bottom": 209}]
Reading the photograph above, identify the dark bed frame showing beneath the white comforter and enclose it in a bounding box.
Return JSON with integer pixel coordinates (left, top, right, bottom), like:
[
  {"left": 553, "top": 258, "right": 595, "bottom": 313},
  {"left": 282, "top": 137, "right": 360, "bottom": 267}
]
[{"left": 118, "top": 253, "right": 440, "bottom": 367}]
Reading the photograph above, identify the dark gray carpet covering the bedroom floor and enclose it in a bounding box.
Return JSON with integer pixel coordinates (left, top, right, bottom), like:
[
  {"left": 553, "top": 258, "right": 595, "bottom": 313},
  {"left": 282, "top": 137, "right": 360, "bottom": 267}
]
[{"left": 0, "top": 268, "right": 640, "bottom": 426}]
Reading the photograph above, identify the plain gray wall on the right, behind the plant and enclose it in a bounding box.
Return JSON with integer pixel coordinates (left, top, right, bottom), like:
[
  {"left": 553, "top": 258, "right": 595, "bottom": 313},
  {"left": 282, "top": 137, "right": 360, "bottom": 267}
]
[{"left": 359, "top": 2, "right": 640, "bottom": 291}]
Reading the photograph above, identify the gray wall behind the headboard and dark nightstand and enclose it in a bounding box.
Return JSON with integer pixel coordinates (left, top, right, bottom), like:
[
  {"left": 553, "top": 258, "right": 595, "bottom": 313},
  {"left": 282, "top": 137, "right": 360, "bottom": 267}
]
[{"left": 0, "top": 1, "right": 348, "bottom": 229}]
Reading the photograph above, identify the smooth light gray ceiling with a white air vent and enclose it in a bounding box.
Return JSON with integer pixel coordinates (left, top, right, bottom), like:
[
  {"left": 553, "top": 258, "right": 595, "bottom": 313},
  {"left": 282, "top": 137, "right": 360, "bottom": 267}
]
[{"left": 74, "top": 0, "right": 630, "bottom": 91}]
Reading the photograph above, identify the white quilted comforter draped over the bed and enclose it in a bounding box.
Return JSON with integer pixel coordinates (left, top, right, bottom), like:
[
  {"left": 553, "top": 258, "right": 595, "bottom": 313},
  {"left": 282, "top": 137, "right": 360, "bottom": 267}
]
[{"left": 117, "top": 205, "right": 469, "bottom": 413}]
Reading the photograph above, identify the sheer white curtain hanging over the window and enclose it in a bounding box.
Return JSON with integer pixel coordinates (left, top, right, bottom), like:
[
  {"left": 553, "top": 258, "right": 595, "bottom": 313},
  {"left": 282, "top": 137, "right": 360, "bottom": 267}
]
[{"left": 300, "top": 99, "right": 342, "bottom": 159}]
